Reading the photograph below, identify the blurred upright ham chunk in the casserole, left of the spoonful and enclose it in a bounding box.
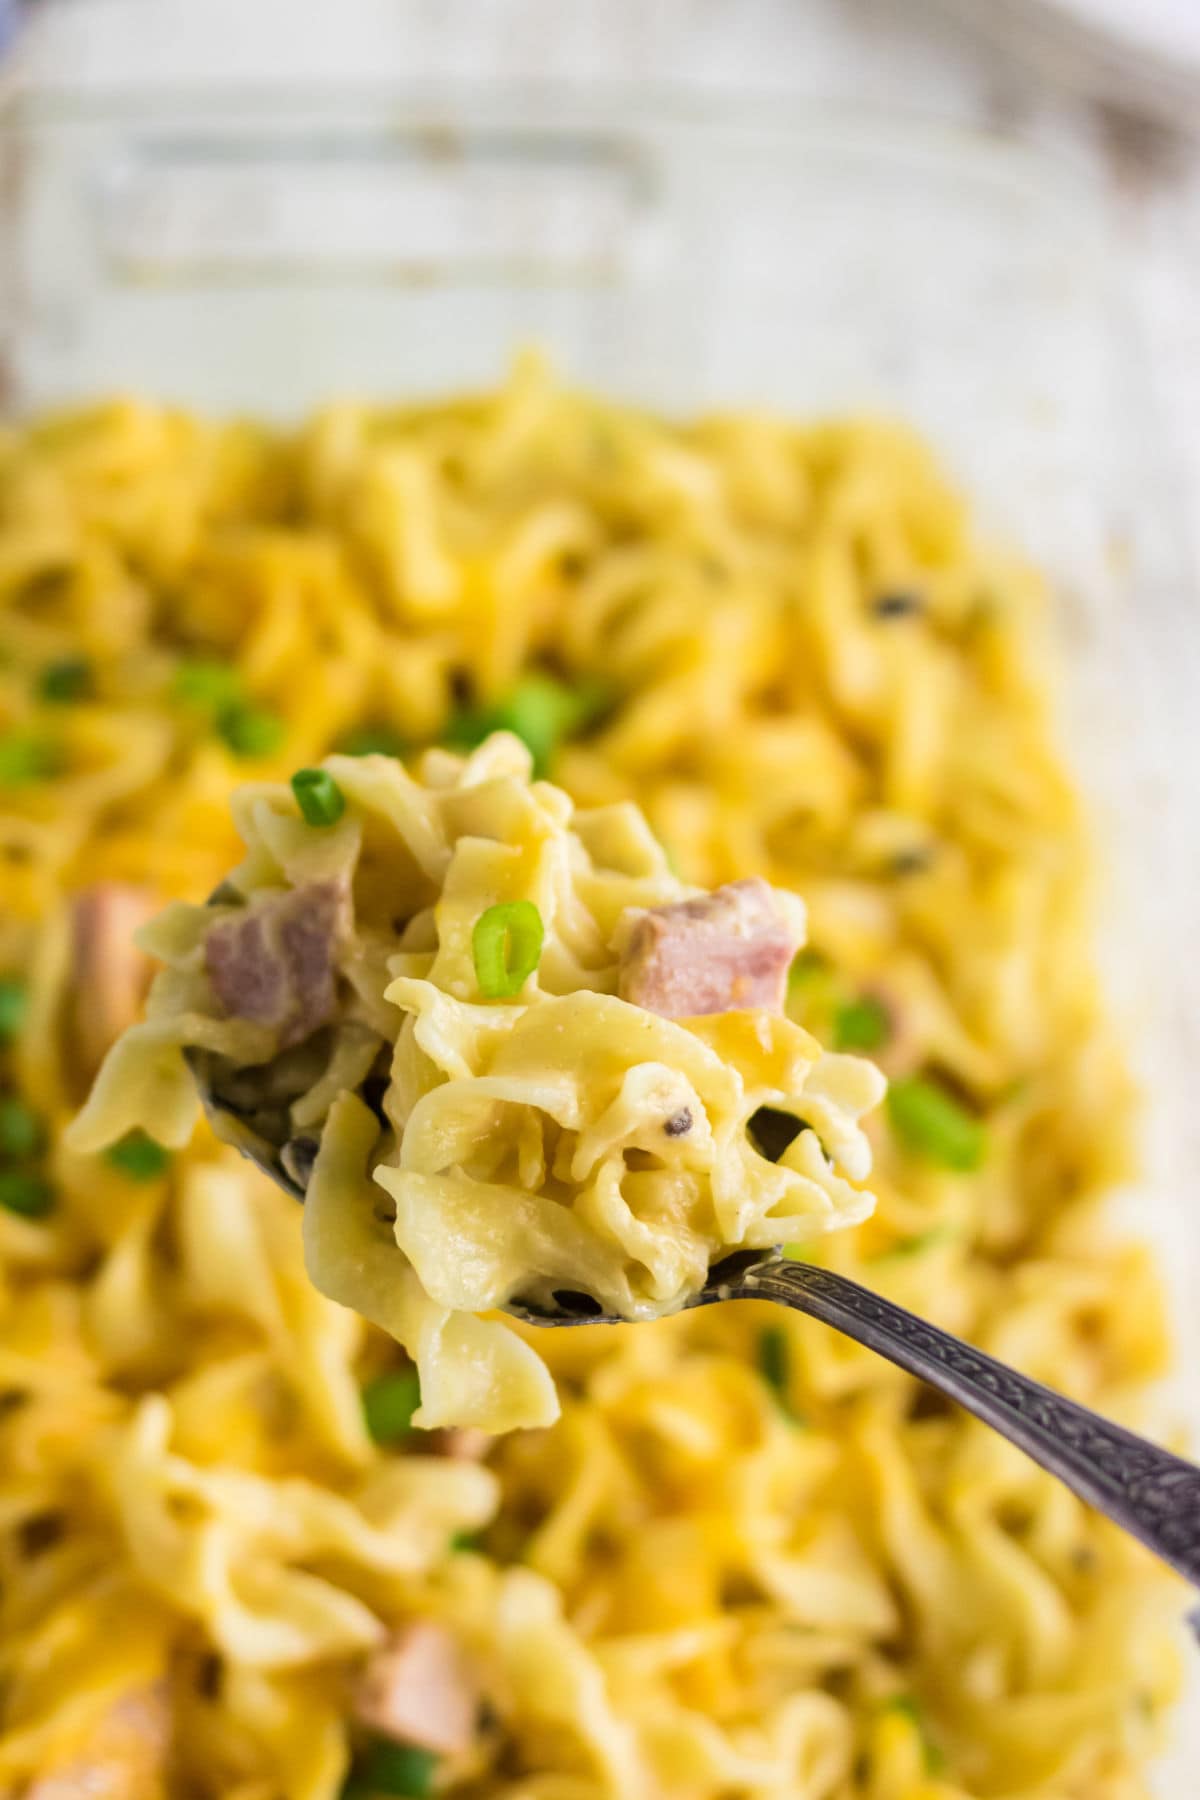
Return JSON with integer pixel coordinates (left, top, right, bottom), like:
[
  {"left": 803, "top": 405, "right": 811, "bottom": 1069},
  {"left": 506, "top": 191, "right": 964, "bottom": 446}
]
[{"left": 68, "top": 882, "right": 155, "bottom": 1080}]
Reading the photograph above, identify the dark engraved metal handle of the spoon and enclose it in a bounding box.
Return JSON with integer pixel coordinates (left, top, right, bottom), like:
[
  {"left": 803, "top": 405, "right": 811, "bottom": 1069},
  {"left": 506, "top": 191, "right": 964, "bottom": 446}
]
[{"left": 727, "top": 1258, "right": 1200, "bottom": 1586}]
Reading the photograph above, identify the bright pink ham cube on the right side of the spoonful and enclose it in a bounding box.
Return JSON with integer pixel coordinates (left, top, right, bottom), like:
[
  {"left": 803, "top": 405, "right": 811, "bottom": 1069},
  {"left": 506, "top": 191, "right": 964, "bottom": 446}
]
[{"left": 617, "top": 877, "right": 804, "bottom": 1019}]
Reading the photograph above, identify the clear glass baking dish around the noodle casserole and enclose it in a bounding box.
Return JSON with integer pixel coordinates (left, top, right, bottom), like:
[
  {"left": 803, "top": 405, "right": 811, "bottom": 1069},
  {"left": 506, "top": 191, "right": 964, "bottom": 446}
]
[{"left": 0, "top": 86, "right": 1200, "bottom": 1800}]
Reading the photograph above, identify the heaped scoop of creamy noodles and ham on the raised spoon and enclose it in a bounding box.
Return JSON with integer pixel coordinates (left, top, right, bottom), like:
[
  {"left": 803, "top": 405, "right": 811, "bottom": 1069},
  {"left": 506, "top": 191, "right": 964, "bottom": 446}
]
[{"left": 72, "top": 733, "right": 883, "bottom": 1431}]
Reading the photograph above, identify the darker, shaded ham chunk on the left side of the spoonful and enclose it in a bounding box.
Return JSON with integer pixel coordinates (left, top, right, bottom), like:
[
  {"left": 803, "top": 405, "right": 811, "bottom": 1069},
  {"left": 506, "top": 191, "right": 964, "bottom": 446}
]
[{"left": 205, "top": 880, "right": 349, "bottom": 1049}]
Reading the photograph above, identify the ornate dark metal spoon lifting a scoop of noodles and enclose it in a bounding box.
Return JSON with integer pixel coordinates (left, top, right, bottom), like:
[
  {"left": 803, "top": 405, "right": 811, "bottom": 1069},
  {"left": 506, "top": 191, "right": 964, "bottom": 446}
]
[{"left": 187, "top": 1049, "right": 1200, "bottom": 1598}]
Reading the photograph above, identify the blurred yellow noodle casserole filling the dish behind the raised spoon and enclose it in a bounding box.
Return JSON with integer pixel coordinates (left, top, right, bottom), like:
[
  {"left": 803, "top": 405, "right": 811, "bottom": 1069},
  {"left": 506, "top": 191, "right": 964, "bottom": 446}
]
[{"left": 0, "top": 360, "right": 1180, "bottom": 1800}]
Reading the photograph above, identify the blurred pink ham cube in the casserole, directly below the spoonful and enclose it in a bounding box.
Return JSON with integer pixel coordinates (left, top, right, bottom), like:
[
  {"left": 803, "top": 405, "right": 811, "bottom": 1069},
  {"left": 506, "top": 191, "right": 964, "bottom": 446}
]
[{"left": 353, "top": 1618, "right": 480, "bottom": 1757}]
